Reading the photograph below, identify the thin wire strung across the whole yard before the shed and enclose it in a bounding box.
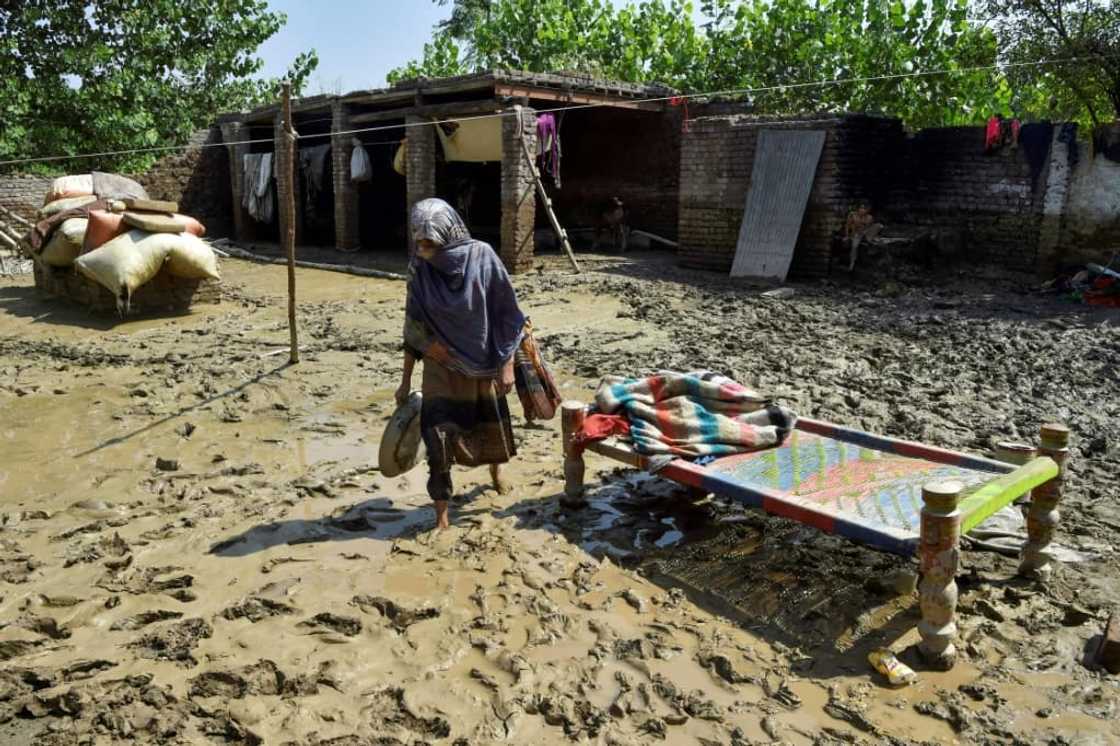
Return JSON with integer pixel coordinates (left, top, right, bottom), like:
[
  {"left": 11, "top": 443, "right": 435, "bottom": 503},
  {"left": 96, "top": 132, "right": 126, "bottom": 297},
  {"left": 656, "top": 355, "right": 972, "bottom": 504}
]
[{"left": 0, "top": 55, "right": 1120, "bottom": 166}]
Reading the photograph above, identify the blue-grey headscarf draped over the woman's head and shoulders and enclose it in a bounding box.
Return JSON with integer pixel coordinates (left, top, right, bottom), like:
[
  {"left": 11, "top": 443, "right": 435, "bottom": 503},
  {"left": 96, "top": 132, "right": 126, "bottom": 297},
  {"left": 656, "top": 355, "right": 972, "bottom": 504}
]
[{"left": 404, "top": 199, "right": 525, "bottom": 379}]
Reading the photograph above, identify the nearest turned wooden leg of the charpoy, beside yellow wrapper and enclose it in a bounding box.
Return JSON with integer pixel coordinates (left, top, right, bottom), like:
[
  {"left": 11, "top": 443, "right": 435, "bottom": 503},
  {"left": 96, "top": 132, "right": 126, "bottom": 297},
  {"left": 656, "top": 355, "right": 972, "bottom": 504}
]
[{"left": 917, "top": 482, "right": 963, "bottom": 671}]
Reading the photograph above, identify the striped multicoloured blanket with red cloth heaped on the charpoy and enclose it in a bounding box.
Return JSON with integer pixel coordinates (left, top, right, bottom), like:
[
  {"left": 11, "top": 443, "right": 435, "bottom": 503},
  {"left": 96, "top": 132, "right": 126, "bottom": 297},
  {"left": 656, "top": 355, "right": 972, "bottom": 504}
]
[{"left": 575, "top": 371, "right": 797, "bottom": 472}]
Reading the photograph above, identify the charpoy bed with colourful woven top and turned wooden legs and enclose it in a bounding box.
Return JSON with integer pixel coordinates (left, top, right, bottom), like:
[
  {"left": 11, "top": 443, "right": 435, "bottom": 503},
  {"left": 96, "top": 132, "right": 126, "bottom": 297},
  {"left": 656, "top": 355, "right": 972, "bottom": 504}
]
[{"left": 562, "top": 402, "right": 1070, "bottom": 669}]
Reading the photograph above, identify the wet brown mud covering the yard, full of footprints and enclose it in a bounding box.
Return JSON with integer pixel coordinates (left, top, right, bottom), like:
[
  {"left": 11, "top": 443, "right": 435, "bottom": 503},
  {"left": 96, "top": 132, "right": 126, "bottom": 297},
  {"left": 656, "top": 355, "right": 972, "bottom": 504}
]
[{"left": 0, "top": 257, "right": 1120, "bottom": 746}]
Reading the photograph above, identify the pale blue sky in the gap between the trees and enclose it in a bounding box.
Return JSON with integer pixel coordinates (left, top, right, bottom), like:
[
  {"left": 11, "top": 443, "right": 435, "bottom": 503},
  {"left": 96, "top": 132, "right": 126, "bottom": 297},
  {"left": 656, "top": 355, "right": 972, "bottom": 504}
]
[{"left": 259, "top": 0, "right": 699, "bottom": 93}]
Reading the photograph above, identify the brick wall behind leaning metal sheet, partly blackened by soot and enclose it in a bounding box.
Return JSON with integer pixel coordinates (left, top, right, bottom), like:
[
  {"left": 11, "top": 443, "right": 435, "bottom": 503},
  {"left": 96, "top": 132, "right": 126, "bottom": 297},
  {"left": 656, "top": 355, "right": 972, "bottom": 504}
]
[{"left": 680, "top": 114, "right": 1048, "bottom": 278}]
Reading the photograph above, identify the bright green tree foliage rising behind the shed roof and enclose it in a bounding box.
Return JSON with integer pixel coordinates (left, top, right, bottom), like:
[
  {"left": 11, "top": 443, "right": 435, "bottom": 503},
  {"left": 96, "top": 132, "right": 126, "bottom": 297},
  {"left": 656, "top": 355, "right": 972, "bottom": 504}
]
[{"left": 390, "top": 0, "right": 1010, "bottom": 125}]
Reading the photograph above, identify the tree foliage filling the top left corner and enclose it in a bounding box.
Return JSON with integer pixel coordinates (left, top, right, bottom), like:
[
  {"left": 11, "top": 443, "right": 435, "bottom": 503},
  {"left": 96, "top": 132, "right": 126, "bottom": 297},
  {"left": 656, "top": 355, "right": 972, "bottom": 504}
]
[{"left": 0, "top": 0, "right": 318, "bottom": 170}]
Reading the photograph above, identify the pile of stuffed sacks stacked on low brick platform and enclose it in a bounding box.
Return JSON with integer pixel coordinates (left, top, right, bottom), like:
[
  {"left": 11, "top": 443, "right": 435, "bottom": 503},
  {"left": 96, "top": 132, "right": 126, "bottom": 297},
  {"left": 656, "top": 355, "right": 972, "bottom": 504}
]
[{"left": 34, "top": 172, "right": 221, "bottom": 311}]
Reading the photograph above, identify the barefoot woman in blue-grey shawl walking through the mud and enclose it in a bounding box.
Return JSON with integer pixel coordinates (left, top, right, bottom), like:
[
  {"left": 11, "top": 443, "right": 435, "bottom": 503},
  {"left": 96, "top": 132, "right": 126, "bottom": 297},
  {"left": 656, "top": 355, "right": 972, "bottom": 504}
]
[{"left": 396, "top": 199, "right": 525, "bottom": 529}]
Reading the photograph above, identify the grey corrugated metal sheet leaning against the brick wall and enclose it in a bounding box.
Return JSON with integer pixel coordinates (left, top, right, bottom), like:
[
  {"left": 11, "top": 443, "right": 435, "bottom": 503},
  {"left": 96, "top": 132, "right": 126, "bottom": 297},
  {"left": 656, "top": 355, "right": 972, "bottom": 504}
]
[{"left": 731, "top": 130, "right": 824, "bottom": 281}]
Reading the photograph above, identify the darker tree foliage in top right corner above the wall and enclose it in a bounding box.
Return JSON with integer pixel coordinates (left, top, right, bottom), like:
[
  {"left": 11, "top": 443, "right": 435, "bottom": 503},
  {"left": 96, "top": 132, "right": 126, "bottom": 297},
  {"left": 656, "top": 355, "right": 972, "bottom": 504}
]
[{"left": 984, "top": 0, "right": 1120, "bottom": 124}]
